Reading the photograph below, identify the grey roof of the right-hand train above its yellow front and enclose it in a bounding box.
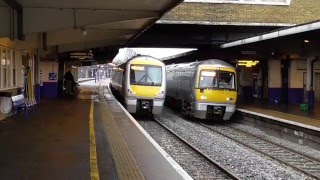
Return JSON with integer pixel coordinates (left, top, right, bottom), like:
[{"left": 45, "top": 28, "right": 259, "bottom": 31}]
[{"left": 167, "top": 59, "right": 235, "bottom": 68}]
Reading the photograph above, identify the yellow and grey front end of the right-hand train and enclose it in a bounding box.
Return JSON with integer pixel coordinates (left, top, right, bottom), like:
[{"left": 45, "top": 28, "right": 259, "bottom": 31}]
[{"left": 193, "top": 65, "right": 237, "bottom": 120}]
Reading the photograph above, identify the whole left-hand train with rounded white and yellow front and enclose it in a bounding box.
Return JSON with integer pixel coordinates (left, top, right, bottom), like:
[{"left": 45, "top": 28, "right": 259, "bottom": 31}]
[{"left": 110, "top": 55, "right": 166, "bottom": 115}]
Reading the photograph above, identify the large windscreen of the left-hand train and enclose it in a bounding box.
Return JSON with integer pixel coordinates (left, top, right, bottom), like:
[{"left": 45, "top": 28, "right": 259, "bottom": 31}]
[{"left": 130, "top": 65, "right": 162, "bottom": 86}]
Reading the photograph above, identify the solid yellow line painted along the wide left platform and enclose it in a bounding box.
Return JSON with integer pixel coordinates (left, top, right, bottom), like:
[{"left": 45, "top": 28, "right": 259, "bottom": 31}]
[{"left": 89, "top": 101, "right": 99, "bottom": 180}]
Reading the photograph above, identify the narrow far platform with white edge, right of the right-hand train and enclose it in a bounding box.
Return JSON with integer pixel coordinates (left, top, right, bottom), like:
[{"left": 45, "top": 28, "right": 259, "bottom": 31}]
[{"left": 234, "top": 102, "right": 320, "bottom": 148}]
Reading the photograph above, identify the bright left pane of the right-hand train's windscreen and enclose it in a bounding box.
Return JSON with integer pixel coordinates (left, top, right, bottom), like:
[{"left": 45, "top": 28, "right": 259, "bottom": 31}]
[{"left": 199, "top": 70, "right": 217, "bottom": 88}]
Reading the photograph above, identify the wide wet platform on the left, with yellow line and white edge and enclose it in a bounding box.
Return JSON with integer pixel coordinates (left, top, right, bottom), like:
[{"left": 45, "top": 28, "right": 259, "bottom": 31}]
[{"left": 0, "top": 81, "right": 191, "bottom": 179}]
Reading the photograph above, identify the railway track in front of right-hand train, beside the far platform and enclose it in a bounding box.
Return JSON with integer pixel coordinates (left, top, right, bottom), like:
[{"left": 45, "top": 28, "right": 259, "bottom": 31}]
[{"left": 199, "top": 123, "right": 320, "bottom": 179}]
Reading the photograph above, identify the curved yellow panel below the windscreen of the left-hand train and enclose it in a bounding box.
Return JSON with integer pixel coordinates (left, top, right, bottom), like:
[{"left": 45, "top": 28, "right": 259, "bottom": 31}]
[{"left": 130, "top": 85, "right": 161, "bottom": 98}]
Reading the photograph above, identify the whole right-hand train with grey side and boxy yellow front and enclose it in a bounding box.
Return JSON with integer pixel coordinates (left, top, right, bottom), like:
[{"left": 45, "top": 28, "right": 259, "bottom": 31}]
[{"left": 166, "top": 59, "right": 237, "bottom": 120}]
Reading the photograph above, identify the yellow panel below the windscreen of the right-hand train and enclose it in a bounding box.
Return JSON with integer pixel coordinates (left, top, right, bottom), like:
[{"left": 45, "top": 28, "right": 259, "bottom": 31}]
[{"left": 196, "top": 89, "right": 237, "bottom": 103}]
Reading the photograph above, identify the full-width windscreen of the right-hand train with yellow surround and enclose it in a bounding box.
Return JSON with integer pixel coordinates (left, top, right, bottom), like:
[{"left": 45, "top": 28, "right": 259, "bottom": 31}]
[{"left": 199, "top": 70, "right": 235, "bottom": 89}]
